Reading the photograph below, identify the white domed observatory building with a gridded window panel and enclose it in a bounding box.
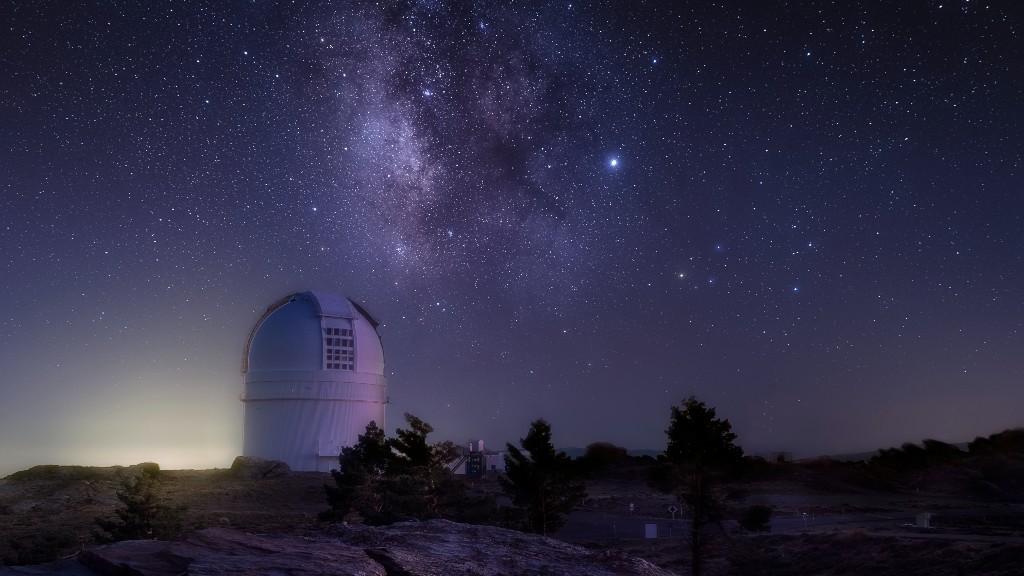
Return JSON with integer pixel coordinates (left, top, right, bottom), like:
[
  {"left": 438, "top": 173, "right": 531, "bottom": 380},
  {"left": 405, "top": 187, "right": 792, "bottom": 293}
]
[{"left": 242, "top": 292, "right": 387, "bottom": 470}]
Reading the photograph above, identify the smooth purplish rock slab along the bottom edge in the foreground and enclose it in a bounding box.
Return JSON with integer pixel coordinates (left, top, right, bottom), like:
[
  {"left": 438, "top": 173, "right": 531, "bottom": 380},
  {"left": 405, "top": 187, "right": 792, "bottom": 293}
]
[{"left": 0, "top": 521, "right": 673, "bottom": 576}]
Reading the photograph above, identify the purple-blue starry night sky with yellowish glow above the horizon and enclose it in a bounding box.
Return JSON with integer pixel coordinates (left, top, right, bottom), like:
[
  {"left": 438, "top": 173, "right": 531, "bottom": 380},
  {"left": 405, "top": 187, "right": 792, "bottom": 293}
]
[{"left": 0, "top": 0, "right": 1024, "bottom": 474}]
